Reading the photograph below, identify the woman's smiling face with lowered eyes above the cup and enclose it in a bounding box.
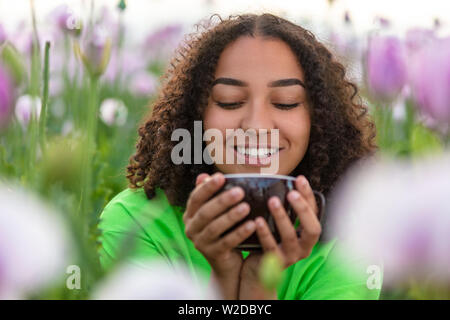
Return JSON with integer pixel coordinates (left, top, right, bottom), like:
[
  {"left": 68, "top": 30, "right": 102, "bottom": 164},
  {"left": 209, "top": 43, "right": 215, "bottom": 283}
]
[{"left": 203, "top": 37, "right": 311, "bottom": 175}]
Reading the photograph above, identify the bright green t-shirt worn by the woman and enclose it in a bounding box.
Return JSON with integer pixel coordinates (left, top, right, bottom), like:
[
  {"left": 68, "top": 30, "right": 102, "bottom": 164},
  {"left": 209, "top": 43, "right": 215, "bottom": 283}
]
[{"left": 99, "top": 188, "right": 380, "bottom": 300}]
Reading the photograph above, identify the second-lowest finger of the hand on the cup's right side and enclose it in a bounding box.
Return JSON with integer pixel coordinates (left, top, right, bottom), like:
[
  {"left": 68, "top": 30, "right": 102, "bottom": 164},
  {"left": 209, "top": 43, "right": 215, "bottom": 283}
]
[{"left": 269, "top": 197, "right": 299, "bottom": 254}]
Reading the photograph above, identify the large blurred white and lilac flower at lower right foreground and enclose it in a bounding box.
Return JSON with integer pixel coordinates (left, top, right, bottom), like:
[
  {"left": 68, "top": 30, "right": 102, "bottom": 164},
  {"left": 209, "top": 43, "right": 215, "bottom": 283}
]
[{"left": 329, "top": 154, "right": 450, "bottom": 293}]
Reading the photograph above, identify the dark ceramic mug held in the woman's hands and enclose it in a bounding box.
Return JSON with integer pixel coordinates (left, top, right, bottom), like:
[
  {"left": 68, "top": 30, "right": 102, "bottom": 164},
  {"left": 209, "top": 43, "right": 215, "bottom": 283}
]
[{"left": 216, "top": 173, "right": 325, "bottom": 250}]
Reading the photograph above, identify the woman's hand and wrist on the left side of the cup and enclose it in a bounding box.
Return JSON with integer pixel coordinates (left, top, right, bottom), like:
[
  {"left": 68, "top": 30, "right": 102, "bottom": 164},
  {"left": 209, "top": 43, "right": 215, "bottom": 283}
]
[{"left": 183, "top": 173, "right": 256, "bottom": 299}]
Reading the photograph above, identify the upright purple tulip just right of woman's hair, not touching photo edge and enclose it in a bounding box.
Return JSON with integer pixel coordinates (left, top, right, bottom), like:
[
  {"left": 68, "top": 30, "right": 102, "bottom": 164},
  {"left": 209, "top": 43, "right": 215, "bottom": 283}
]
[{"left": 367, "top": 36, "right": 407, "bottom": 99}]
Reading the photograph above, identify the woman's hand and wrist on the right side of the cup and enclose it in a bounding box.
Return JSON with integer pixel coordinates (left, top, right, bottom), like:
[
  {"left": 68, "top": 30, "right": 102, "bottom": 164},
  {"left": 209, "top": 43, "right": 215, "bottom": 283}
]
[{"left": 240, "top": 176, "right": 322, "bottom": 299}]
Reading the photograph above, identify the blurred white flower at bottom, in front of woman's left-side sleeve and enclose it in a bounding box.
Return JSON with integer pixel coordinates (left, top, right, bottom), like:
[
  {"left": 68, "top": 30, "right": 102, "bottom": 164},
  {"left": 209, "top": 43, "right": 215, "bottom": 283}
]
[{"left": 92, "top": 260, "right": 220, "bottom": 300}]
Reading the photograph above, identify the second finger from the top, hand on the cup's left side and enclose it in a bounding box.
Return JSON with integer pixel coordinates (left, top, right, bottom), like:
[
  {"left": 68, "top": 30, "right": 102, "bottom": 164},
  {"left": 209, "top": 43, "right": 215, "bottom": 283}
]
[{"left": 188, "top": 187, "right": 245, "bottom": 234}]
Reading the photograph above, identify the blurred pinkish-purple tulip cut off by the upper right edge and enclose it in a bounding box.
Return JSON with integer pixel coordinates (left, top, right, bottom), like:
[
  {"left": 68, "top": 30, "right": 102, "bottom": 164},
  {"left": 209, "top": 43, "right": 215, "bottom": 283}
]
[{"left": 409, "top": 38, "right": 450, "bottom": 124}]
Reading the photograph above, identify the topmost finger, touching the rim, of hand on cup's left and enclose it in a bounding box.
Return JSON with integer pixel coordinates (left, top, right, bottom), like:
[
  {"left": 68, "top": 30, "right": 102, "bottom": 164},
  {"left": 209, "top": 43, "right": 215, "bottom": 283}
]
[{"left": 183, "top": 172, "right": 225, "bottom": 220}]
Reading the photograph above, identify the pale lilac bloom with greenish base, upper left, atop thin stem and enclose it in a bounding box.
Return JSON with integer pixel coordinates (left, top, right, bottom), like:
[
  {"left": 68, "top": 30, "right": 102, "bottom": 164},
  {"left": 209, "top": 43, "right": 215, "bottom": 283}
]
[{"left": 74, "top": 26, "right": 111, "bottom": 77}]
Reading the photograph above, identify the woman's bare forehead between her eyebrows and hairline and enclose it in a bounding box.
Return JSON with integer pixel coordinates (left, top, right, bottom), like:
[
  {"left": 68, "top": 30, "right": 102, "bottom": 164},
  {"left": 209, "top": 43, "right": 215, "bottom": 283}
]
[{"left": 216, "top": 36, "right": 304, "bottom": 81}]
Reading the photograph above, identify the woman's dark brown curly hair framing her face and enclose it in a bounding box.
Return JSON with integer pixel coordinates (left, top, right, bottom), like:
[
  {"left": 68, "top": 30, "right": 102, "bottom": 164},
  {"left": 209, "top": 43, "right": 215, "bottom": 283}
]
[{"left": 127, "top": 13, "right": 378, "bottom": 215}]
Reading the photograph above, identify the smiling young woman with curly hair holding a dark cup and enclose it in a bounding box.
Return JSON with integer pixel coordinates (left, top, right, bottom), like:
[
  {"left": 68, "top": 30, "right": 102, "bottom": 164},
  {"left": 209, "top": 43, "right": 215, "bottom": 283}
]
[{"left": 100, "top": 14, "right": 379, "bottom": 299}]
